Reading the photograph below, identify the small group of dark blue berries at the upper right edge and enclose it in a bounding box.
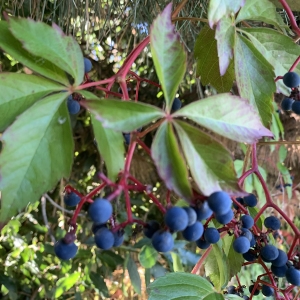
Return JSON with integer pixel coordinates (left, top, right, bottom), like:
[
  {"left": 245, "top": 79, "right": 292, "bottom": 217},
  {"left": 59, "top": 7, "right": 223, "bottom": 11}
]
[{"left": 281, "top": 72, "right": 300, "bottom": 115}]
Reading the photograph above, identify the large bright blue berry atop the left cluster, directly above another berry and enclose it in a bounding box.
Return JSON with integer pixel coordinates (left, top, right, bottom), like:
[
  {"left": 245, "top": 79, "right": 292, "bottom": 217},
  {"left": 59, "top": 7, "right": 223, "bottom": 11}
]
[{"left": 88, "top": 198, "right": 113, "bottom": 223}]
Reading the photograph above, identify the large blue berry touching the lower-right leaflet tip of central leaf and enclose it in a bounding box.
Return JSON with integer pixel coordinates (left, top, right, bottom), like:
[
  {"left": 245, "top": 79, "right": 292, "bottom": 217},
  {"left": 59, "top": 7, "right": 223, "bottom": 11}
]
[{"left": 207, "top": 191, "right": 232, "bottom": 215}]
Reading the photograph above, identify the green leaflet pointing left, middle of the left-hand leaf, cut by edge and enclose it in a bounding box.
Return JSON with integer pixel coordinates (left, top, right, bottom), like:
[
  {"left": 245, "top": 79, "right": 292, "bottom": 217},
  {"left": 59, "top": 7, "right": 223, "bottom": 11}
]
[{"left": 0, "top": 73, "right": 67, "bottom": 132}]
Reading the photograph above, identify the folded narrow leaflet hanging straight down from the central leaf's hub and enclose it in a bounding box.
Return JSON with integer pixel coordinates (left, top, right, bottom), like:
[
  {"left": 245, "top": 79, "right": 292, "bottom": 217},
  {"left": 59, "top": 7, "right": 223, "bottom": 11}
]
[{"left": 151, "top": 122, "right": 192, "bottom": 200}]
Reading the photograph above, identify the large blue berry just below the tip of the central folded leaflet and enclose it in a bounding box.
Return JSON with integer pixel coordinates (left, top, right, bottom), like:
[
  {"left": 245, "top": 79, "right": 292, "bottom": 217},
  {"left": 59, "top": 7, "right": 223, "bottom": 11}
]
[{"left": 165, "top": 206, "right": 189, "bottom": 231}]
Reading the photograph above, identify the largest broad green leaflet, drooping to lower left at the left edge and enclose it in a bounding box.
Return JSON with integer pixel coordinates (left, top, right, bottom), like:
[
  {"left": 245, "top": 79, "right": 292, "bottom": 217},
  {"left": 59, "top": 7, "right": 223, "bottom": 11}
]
[{"left": 0, "top": 93, "right": 73, "bottom": 221}]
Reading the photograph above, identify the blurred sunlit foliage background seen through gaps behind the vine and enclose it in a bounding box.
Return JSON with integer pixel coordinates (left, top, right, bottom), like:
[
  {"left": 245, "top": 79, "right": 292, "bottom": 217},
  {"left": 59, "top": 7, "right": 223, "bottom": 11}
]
[{"left": 0, "top": 0, "right": 300, "bottom": 299}]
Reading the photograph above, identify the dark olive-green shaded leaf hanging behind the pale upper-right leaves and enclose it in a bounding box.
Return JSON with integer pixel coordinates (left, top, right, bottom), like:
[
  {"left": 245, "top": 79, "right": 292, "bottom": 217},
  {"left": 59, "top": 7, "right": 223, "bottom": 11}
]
[{"left": 194, "top": 26, "right": 234, "bottom": 93}]
